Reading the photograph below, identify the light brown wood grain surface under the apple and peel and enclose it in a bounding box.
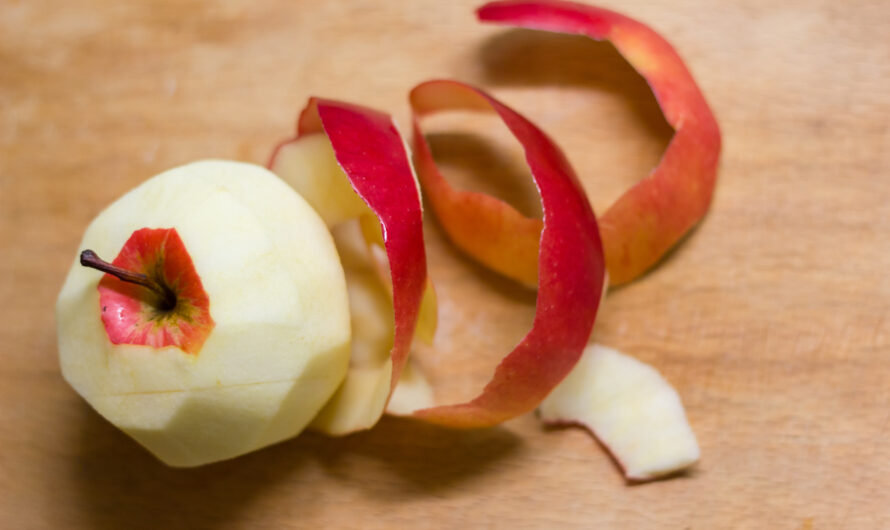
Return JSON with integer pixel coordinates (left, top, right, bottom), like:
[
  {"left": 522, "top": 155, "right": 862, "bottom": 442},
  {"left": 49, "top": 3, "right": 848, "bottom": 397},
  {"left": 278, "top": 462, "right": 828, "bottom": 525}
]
[{"left": 0, "top": 0, "right": 890, "bottom": 529}]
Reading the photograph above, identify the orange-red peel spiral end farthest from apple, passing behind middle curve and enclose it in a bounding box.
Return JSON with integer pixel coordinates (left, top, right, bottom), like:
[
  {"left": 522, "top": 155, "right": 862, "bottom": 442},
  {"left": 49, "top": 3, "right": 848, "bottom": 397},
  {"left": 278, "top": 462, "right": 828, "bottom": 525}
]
[{"left": 415, "top": 0, "right": 721, "bottom": 285}]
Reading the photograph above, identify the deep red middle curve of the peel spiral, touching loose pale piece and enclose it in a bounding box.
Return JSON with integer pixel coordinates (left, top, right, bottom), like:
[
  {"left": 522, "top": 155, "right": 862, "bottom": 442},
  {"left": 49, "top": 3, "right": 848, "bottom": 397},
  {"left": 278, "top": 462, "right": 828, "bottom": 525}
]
[{"left": 411, "top": 81, "right": 605, "bottom": 428}]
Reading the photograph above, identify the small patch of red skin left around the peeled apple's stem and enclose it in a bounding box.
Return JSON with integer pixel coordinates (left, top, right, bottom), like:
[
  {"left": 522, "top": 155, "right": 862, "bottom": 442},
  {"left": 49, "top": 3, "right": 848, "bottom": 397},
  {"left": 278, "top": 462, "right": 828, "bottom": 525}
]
[{"left": 90, "top": 228, "right": 215, "bottom": 355}]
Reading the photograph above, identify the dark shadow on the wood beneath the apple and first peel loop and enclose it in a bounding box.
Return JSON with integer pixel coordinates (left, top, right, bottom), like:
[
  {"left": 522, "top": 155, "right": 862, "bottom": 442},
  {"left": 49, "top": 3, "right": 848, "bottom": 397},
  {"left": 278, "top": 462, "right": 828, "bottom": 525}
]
[{"left": 74, "top": 405, "right": 519, "bottom": 529}]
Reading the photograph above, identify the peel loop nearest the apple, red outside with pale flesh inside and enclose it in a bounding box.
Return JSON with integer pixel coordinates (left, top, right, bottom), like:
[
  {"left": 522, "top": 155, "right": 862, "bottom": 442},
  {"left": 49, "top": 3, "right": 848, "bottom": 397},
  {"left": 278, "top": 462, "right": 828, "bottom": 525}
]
[{"left": 269, "top": 98, "right": 426, "bottom": 435}]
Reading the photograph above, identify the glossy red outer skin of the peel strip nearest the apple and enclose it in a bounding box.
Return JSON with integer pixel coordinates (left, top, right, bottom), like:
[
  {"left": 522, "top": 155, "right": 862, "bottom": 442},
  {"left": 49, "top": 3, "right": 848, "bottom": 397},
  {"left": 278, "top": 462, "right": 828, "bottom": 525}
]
[{"left": 268, "top": 98, "right": 427, "bottom": 395}]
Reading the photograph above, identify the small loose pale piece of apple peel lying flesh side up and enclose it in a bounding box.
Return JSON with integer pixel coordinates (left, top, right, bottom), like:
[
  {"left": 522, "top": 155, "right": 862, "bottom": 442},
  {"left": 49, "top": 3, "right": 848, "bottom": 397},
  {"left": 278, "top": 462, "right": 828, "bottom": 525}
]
[{"left": 538, "top": 344, "right": 699, "bottom": 481}]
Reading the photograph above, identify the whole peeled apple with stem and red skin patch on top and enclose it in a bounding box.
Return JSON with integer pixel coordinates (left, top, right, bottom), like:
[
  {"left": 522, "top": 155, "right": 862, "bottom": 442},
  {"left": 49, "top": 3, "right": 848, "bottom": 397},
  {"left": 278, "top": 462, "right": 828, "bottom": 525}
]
[{"left": 56, "top": 161, "right": 350, "bottom": 466}]
